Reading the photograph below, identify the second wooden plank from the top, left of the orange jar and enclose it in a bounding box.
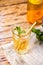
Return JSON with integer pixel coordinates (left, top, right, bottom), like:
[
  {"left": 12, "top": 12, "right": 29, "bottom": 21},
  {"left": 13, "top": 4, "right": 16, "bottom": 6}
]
[{"left": 0, "top": 3, "right": 27, "bottom": 16}]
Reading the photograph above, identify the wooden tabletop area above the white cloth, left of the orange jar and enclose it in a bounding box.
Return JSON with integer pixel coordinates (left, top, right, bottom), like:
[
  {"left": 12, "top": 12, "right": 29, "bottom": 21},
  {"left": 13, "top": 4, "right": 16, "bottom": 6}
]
[{"left": 0, "top": 0, "right": 27, "bottom": 45}]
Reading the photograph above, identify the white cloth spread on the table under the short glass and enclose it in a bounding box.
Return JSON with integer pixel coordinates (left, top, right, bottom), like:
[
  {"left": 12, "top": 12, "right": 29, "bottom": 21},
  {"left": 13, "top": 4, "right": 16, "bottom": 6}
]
[{"left": 2, "top": 40, "right": 43, "bottom": 65}]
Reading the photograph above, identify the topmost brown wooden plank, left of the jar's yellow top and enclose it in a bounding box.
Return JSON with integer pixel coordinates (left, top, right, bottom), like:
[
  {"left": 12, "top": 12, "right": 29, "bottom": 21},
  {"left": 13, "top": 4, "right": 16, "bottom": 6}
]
[{"left": 0, "top": 0, "right": 27, "bottom": 6}]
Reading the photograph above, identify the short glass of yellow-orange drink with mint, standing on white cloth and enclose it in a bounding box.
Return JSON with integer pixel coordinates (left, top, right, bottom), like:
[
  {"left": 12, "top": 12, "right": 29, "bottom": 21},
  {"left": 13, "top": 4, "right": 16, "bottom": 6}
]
[{"left": 12, "top": 22, "right": 32, "bottom": 54}]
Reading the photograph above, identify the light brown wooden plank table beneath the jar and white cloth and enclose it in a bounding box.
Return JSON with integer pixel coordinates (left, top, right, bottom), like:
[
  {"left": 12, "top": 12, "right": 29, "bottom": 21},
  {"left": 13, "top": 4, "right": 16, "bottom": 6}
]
[{"left": 0, "top": 0, "right": 27, "bottom": 65}]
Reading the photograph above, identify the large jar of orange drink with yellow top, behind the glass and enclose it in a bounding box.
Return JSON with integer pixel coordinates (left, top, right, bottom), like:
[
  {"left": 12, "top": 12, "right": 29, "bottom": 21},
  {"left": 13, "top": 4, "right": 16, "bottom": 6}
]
[{"left": 27, "top": 0, "right": 43, "bottom": 24}]
